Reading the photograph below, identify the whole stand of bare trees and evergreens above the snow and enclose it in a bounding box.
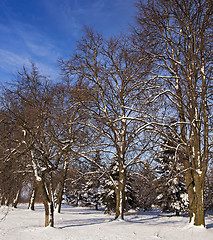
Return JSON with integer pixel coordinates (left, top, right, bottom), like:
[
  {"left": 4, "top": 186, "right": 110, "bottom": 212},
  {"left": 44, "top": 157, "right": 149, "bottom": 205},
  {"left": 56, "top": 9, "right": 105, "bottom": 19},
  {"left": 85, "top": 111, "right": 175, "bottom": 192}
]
[{"left": 0, "top": 0, "right": 213, "bottom": 227}]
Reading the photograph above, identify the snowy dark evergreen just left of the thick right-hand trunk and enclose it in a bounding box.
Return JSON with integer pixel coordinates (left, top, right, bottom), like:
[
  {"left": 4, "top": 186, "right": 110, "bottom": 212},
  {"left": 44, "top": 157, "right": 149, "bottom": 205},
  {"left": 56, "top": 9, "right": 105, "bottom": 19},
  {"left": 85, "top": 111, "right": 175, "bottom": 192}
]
[{"left": 155, "top": 121, "right": 188, "bottom": 216}]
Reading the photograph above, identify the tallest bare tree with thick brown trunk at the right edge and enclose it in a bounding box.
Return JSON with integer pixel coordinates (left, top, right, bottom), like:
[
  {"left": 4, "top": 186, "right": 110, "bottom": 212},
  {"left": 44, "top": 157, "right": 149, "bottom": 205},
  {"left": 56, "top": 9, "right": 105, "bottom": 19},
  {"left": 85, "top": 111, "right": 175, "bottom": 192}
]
[{"left": 135, "top": 0, "right": 212, "bottom": 225}]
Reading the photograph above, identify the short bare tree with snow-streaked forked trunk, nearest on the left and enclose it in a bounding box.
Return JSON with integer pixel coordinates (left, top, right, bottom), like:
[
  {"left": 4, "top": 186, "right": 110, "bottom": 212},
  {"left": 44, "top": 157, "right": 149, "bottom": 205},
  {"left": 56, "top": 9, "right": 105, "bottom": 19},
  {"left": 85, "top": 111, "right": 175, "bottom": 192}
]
[{"left": 1, "top": 65, "right": 72, "bottom": 226}]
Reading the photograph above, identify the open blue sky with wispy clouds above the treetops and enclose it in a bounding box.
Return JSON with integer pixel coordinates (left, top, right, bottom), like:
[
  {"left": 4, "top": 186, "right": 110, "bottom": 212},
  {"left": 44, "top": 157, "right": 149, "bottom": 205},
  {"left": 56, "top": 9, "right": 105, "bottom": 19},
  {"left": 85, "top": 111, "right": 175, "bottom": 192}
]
[{"left": 0, "top": 0, "right": 135, "bottom": 83}]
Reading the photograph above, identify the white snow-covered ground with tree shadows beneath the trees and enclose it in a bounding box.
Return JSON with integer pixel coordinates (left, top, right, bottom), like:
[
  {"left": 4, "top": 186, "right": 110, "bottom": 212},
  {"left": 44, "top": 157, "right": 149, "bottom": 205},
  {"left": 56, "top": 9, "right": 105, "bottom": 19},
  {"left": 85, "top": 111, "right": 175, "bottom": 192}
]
[{"left": 0, "top": 205, "right": 213, "bottom": 240}]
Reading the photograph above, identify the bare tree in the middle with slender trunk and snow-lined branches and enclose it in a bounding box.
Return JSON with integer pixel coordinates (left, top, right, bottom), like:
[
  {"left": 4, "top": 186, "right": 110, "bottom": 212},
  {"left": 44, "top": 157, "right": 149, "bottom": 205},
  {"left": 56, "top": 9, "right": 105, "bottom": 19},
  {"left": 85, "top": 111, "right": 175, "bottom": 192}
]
[{"left": 61, "top": 29, "right": 156, "bottom": 219}]
